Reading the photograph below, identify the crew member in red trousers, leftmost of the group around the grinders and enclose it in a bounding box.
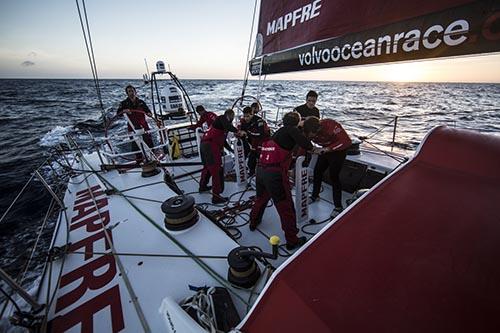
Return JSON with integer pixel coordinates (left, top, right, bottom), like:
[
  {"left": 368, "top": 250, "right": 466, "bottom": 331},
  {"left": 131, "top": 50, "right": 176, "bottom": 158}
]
[{"left": 199, "top": 109, "right": 245, "bottom": 204}]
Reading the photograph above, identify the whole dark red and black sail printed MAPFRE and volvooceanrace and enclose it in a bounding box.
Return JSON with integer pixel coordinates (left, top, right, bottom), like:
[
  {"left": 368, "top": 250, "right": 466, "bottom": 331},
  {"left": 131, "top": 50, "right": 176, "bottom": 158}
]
[{"left": 250, "top": 0, "right": 500, "bottom": 75}]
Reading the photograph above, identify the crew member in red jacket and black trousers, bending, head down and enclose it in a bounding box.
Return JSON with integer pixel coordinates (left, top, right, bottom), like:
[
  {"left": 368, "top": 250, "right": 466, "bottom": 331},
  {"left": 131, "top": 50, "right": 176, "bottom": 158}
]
[{"left": 311, "top": 118, "right": 352, "bottom": 216}]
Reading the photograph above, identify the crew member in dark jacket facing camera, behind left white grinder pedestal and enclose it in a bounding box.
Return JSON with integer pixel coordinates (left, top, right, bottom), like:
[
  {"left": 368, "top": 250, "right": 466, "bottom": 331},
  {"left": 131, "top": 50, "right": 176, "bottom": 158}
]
[{"left": 240, "top": 106, "right": 270, "bottom": 177}]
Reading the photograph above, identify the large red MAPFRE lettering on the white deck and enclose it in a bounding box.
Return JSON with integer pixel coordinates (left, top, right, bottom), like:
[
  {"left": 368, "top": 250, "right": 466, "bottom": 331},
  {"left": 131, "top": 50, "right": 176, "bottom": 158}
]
[{"left": 50, "top": 185, "right": 125, "bottom": 332}]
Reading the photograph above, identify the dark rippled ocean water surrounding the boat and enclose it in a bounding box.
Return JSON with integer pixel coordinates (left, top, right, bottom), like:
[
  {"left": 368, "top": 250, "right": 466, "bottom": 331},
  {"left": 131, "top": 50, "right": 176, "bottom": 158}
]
[{"left": 0, "top": 80, "right": 500, "bottom": 296}]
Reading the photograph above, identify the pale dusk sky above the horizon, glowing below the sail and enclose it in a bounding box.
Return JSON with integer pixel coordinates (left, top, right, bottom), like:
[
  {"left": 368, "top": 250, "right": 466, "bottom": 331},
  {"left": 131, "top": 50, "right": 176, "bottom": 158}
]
[{"left": 0, "top": 0, "right": 500, "bottom": 82}]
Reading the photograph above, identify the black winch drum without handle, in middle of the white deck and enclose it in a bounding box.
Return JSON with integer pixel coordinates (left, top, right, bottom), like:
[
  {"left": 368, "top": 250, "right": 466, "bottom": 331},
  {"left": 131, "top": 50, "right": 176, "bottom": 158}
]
[{"left": 161, "top": 195, "right": 199, "bottom": 231}]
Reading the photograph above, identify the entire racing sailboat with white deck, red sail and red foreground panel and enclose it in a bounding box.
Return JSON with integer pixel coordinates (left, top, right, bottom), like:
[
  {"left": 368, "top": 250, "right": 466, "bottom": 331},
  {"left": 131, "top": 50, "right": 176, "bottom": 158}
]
[{"left": 2, "top": 0, "right": 500, "bottom": 332}]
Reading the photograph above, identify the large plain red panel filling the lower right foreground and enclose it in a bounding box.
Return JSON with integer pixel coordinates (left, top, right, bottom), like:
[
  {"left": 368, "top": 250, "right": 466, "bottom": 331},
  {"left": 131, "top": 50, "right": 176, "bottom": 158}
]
[{"left": 242, "top": 127, "right": 500, "bottom": 333}]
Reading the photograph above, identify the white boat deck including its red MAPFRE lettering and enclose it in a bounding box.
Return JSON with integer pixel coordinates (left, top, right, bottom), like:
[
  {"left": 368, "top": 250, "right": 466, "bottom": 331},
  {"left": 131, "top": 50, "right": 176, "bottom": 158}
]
[{"left": 35, "top": 144, "right": 396, "bottom": 332}]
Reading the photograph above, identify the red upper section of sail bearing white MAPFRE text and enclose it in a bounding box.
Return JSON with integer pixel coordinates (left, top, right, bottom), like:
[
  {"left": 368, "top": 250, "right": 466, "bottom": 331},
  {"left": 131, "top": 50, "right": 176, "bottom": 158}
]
[{"left": 258, "top": 0, "right": 474, "bottom": 54}]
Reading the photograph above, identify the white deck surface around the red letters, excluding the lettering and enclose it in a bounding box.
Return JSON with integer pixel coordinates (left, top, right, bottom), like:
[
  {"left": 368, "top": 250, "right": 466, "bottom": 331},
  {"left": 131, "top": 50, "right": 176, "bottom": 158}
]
[{"left": 35, "top": 147, "right": 400, "bottom": 332}]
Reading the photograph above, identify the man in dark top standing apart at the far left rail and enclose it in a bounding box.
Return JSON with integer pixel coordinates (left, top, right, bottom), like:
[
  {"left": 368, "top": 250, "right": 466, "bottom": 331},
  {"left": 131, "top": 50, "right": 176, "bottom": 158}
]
[{"left": 116, "top": 85, "right": 153, "bottom": 162}]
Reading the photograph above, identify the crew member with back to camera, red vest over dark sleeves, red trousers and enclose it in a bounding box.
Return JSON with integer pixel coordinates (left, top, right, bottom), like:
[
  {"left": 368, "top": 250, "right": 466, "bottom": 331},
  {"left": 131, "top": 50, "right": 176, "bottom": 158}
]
[{"left": 250, "top": 112, "right": 319, "bottom": 250}]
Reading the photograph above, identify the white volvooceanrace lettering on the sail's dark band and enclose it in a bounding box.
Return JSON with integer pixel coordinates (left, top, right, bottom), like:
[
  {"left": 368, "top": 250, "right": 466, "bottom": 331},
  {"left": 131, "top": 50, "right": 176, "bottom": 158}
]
[{"left": 298, "top": 19, "right": 469, "bottom": 66}]
